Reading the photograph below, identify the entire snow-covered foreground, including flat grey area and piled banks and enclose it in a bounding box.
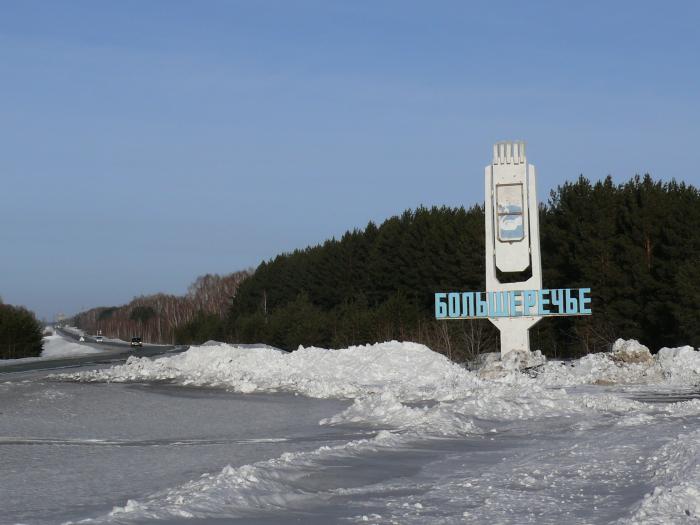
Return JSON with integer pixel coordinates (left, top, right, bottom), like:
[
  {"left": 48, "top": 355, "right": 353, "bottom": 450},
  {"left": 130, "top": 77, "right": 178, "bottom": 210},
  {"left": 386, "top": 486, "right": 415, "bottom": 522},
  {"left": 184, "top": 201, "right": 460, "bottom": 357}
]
[{"left": 0, "top": 341, "right": 700, "bottom": 524}]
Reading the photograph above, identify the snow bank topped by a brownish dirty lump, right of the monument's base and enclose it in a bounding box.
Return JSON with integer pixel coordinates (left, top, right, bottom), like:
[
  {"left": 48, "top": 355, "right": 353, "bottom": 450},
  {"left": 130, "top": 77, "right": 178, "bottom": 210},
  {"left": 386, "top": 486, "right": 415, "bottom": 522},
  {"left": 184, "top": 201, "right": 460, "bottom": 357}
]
[{"left": 537, "top": 339, "right": 700, "bottom": 386}]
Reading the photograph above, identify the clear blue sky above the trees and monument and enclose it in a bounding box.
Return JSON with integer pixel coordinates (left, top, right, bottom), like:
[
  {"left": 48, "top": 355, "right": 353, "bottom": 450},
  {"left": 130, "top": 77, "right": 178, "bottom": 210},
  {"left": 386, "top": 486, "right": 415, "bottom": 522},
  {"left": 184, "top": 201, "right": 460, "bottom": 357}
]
[{"left": 0, "top": 0, "right": 700, "bottom": 318}]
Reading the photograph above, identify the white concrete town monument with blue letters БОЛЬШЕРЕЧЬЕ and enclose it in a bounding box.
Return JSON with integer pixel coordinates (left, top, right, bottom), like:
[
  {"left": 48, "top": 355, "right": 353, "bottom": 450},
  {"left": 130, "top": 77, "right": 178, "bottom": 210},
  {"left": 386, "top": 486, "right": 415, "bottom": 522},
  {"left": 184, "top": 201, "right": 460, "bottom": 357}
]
[{"left": 435, "top": 141, "right": 591, "bottom": 356}]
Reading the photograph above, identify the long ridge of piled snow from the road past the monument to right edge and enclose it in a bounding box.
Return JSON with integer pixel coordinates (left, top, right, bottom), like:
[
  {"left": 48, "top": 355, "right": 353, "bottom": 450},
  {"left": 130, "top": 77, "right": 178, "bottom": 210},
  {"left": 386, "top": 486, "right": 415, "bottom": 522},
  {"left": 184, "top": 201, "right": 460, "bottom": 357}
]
[{"left": 61, "top": 339, "right": 700, "bottom": 396}]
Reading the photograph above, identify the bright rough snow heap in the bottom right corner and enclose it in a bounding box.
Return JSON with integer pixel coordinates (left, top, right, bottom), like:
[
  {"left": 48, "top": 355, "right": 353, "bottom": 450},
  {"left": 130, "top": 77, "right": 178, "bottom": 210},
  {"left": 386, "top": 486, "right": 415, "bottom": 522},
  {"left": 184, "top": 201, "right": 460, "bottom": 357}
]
[{"left": 628, "top": 431, "right": 700, "bottom": 525}]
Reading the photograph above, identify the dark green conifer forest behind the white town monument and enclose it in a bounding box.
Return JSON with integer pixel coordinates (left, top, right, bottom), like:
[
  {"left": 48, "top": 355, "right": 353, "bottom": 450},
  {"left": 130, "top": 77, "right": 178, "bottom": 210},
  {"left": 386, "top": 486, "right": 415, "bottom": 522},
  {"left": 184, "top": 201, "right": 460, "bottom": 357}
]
[{"left": 72, "top": 175, "right": 700, "bottom": 360}]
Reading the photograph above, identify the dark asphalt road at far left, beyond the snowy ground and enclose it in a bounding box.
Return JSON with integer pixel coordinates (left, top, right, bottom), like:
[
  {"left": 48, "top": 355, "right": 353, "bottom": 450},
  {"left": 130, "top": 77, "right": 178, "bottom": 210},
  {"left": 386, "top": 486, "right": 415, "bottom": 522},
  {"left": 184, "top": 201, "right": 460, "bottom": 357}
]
[{"left": 0, "top": 329, "right": 189, "bottom": 376}]
